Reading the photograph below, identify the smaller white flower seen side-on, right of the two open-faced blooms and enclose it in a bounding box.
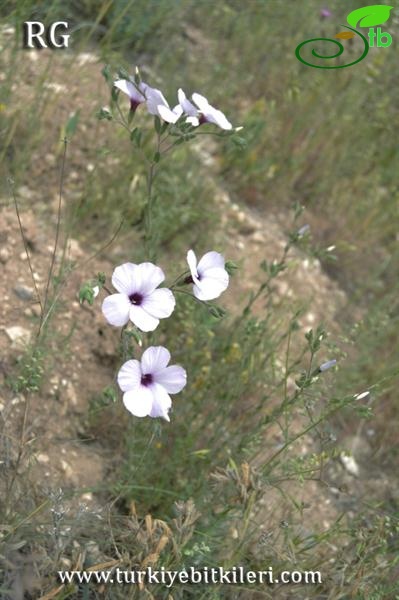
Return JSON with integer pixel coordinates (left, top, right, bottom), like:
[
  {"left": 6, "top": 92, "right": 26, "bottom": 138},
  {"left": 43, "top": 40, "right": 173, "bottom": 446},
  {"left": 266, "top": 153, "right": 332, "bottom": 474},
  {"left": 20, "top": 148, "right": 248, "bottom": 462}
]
[{"left": 187, "top": 250, "right": 229, "bottom": 300}]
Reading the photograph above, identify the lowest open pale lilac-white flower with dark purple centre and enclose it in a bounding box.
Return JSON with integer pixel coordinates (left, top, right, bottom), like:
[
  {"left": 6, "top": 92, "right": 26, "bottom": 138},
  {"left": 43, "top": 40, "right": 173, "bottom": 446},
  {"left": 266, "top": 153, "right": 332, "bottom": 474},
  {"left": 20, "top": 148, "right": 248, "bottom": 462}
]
[{"left": 118, "top": 346, "right": 187, "bottom": 421}]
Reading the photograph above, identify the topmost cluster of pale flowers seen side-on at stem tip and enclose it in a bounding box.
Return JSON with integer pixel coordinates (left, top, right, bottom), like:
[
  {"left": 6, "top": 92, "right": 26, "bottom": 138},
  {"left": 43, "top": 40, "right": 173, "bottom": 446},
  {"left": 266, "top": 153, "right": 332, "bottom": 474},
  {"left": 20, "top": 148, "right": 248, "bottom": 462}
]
[{"left": 114, "top": 78, "right": 233, "bottom": 131}]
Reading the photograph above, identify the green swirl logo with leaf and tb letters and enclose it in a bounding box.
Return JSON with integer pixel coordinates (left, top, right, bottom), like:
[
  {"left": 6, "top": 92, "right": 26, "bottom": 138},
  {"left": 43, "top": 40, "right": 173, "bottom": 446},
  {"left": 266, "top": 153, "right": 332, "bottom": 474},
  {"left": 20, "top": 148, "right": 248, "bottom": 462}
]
[{"left": 295, "top": 4, "right": 393, "bottom": 69}]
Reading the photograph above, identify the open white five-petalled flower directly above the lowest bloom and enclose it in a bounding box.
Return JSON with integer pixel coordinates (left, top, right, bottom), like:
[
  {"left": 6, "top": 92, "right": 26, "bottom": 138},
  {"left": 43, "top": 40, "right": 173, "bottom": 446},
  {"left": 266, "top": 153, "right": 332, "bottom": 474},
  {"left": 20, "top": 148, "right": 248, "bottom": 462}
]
[{"left": 102, "top": 262, "right": 175, "bottom": 331}]
